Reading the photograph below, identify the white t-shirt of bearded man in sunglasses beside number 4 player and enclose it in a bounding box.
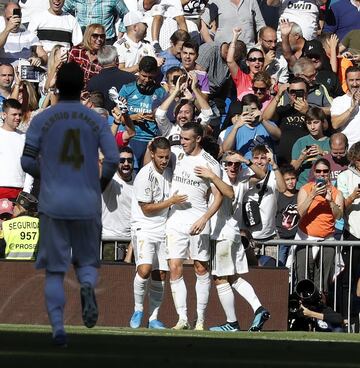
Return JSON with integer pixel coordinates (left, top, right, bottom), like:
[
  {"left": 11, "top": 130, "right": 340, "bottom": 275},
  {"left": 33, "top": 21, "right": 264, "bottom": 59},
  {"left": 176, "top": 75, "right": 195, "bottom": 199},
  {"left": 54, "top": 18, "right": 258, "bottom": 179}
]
[{"left": 102, "top": 173, "right": 133, "bottom": 238}]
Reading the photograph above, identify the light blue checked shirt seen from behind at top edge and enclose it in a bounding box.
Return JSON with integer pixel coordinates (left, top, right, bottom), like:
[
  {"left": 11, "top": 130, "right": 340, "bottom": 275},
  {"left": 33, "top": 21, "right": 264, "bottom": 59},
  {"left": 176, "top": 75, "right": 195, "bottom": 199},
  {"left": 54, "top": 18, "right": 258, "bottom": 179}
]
[{"left": 63, "top": 0, "right": 128, "bottom": 39}]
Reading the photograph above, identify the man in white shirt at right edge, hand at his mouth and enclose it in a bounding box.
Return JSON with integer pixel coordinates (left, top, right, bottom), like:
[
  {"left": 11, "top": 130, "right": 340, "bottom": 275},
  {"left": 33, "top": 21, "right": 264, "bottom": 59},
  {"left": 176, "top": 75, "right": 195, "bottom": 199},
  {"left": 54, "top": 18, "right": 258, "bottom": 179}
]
[{"left": 330, "top": 66, "right": 360, "bottom": 147}]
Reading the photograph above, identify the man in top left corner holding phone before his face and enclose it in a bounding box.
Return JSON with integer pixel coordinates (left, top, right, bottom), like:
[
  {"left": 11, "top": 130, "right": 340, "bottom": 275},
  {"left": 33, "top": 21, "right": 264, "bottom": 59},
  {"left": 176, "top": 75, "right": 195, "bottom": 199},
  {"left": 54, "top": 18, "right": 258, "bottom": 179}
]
[{"left": 0, "top": 3, "right": 47, "bottom": 67}]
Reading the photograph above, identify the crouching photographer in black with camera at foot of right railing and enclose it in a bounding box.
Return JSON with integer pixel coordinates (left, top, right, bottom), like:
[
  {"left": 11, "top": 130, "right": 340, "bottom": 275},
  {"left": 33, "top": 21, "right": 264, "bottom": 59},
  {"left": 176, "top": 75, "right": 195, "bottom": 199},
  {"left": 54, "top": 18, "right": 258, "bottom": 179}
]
[{"left": 289, "top": 279, "right": 344, "bottom": 332}]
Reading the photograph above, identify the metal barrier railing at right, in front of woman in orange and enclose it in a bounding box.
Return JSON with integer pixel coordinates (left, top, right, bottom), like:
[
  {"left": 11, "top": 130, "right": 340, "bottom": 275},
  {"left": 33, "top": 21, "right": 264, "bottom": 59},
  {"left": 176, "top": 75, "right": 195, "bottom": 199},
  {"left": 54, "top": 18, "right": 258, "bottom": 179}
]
[{"left": 255, "top": 239, "right": 360, "bottom": 332}]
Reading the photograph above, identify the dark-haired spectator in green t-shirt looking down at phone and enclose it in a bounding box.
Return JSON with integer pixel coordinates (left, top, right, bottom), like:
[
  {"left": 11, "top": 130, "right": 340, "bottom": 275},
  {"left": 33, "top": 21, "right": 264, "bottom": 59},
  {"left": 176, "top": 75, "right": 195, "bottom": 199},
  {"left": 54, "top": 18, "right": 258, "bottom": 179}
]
[{"left": 291, "top": 107, "right": 330, "bottom": 189}]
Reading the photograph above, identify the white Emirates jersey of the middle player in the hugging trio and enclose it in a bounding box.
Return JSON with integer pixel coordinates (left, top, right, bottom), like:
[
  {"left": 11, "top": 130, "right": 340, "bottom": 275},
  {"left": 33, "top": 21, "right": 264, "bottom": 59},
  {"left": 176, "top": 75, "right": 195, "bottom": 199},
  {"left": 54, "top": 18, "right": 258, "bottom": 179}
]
[{"left": 168, "top": 150, "right": 221, "bottom": 225}]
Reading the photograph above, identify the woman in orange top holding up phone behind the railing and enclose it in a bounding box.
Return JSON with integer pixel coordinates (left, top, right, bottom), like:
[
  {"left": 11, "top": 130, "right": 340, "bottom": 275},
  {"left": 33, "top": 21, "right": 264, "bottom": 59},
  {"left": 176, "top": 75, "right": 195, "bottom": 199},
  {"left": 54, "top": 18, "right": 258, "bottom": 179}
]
[{"left": 293, "top": 158, "right": 344, "bottom": 292}]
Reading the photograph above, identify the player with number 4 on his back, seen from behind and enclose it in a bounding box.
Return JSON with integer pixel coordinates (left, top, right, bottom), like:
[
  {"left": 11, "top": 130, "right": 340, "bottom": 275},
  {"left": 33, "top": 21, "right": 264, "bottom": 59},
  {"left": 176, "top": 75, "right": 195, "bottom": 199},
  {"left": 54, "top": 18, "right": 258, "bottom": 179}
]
[{"left": 21, "top": 63, "right": 119, "bottom": 346}]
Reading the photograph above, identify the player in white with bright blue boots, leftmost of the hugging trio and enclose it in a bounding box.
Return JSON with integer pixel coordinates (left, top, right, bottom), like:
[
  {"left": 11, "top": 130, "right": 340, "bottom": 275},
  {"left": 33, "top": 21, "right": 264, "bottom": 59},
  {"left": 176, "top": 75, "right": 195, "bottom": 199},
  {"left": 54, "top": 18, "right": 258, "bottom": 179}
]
[{"left": 130, "top": 137, "right": 187, "bottom": 329}]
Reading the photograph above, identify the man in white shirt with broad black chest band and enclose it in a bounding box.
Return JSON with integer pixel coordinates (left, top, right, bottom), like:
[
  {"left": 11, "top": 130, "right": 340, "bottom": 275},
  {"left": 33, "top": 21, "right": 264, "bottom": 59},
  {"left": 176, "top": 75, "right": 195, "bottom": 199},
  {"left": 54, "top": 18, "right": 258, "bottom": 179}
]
[{"left": 28, "top": 0, "right": 83, "bottom": 53}]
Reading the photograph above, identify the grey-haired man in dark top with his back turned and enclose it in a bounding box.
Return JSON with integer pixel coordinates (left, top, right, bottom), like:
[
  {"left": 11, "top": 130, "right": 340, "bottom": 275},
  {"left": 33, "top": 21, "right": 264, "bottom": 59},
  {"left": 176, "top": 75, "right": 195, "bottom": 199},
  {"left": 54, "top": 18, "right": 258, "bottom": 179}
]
[{"left": 87, "top": 45, "right": 136, "bottom": 112}]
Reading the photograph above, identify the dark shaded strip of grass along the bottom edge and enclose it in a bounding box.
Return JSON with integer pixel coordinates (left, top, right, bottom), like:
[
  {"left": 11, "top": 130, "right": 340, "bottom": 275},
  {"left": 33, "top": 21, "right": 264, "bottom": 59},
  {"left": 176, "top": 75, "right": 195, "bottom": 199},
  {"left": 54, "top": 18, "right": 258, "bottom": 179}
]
[{"left": 0, "top": 331, "right": 360, "bottom": 368}]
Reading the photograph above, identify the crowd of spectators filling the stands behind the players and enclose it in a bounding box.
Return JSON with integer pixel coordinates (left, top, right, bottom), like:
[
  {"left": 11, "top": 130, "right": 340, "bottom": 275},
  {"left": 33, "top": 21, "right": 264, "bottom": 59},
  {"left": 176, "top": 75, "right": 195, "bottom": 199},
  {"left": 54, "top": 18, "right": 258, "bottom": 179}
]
[{"left": 0, "top": 0, "right": 360, "bottom": 330}]
